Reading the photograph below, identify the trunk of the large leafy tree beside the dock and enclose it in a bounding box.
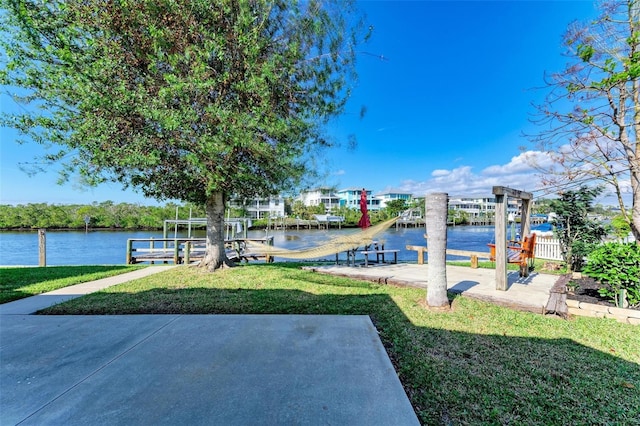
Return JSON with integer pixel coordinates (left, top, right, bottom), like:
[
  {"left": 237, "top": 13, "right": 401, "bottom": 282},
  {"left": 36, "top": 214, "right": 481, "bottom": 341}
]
[{"left": 200, "top": 192, "right": 233, "bottom": 271}]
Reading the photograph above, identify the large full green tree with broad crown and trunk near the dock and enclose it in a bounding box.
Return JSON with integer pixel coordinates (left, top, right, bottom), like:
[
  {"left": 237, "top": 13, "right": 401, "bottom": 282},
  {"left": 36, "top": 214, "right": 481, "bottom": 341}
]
[{"left": 0, "top": 0, "right": 363, "bottom": 269}]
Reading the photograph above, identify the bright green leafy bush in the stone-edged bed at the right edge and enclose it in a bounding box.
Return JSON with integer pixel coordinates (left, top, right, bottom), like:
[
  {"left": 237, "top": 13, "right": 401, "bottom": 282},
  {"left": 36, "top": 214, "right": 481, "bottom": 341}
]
[{"left": 583, "top": 243, "right": 640, "bottom": 306}]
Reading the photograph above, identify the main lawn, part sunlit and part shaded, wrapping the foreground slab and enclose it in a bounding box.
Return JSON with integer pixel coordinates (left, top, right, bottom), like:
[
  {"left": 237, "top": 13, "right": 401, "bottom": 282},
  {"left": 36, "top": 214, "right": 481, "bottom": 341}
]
[{"left": 36, "top": 263, "right": 640, "bottom": 425}]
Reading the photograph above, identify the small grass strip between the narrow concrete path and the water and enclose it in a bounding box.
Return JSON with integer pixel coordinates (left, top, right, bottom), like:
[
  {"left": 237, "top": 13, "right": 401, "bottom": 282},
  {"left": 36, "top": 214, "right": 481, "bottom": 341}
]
[{"left": 0, "top": 265, "right": 144, "bottom": 303}]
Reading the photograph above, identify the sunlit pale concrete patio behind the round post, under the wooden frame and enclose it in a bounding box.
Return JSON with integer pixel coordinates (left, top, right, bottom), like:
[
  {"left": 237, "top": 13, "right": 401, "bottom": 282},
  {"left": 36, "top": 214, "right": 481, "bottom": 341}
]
[{"left": 310, "top": 264, "right": 558, "bottom": 313}]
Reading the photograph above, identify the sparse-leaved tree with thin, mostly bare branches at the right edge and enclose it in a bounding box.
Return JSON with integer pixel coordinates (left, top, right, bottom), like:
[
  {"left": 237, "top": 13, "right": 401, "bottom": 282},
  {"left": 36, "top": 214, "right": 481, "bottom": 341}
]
[{"left": 534, "top": 0, "right": 640, "bottom": 243}]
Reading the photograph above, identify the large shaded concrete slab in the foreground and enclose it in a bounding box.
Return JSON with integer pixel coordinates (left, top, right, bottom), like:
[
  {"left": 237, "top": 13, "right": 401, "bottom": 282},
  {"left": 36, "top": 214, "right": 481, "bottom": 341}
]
[{"left": 0, "top": 315, "right": 419, "bottom": 425}]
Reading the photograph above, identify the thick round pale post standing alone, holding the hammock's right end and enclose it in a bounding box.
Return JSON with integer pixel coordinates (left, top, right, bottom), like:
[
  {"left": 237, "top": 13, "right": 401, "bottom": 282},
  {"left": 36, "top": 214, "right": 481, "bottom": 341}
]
[{"left": 425, "top": 193, "right": 449, "bottom": 309}]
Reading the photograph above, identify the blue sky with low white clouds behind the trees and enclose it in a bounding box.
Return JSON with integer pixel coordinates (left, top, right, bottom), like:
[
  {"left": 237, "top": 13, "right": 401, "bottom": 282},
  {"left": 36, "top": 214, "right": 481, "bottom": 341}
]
[{"left": 0, "top": 1, "right": 597, "bottom": 204}]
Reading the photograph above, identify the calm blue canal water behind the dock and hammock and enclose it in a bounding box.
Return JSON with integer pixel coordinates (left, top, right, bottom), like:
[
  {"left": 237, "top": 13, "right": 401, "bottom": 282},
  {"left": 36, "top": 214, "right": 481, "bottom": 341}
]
[{"left": 0, "top": 226, "right": 494, "bottom": 266}]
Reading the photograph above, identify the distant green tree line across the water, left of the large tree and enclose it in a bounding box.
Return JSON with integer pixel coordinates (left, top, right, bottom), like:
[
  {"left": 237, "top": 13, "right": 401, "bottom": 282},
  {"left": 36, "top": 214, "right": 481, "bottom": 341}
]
[{"left": 0, "top": 201, "right": 205, "bottom": 230}]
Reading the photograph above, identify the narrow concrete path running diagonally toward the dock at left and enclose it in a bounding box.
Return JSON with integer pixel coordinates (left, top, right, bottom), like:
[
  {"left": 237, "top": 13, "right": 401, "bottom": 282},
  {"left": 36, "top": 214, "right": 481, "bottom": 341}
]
[{"left": 0, "top": 265, "right": 176, "bottom": 315}]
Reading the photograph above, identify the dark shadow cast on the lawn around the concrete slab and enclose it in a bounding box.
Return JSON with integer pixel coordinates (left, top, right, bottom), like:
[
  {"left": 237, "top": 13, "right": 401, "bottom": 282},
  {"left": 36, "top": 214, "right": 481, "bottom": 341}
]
[{"left": 42, "top": 272, "right": 640, "bottom": 424}]
